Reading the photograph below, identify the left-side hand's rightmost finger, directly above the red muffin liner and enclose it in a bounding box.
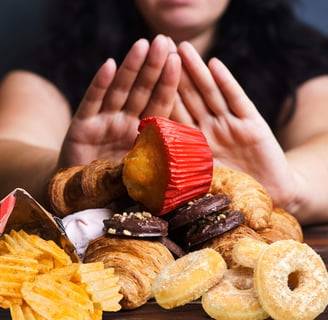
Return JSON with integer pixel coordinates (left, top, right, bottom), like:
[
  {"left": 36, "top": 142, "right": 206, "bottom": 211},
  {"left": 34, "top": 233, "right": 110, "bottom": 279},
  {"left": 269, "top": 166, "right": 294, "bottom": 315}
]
[{"left": 141, "top": 53, "right": 181, "bottom": 117}]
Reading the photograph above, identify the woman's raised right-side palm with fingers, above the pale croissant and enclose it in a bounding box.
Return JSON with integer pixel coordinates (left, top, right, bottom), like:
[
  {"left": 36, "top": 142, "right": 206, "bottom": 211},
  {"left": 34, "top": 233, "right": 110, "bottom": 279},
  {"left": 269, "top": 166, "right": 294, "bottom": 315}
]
[{"left": 171, "top": 42, "right": 296, "bottom": 206}]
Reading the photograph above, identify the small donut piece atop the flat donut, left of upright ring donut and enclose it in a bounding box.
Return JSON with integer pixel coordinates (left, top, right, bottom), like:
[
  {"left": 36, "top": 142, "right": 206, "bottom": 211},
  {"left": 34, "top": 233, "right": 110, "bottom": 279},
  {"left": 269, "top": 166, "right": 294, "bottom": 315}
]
[{"left": 231, "top": 237, "right": 269, "bottom": 268}]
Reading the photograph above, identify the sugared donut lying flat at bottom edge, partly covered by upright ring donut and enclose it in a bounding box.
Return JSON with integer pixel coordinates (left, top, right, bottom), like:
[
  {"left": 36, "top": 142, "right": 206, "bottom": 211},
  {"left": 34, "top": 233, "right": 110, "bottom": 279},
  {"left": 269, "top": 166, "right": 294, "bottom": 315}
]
[{"left": 201, "top": 267, "right": 269, "bottom": 320}]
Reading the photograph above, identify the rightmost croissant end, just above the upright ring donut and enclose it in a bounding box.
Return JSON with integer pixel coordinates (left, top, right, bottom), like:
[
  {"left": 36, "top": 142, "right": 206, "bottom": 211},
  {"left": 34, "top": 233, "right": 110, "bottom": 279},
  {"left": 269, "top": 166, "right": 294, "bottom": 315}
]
[{"left": 258, "top": 208, "right": 303, "bottom": 243}]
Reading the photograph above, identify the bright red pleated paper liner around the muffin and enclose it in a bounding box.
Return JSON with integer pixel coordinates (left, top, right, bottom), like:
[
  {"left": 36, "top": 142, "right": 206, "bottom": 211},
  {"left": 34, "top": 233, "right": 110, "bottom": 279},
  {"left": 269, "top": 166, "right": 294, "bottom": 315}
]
[{"left": 139, "top": 117, "right": 213, "bottom": 215}]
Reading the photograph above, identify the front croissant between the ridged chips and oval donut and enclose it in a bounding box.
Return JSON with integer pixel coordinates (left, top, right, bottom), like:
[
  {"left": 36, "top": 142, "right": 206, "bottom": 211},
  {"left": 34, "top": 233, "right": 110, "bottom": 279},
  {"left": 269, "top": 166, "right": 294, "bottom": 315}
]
[{"left": 84, "top": 236, "right": 174, "bottom": 310}]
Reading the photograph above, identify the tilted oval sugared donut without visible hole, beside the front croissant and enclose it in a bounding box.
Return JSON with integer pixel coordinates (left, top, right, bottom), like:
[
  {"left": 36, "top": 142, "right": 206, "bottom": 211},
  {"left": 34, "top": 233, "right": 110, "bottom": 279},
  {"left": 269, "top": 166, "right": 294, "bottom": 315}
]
[{"left": 152, "top": 248, "right": 227, "bottom": 309}]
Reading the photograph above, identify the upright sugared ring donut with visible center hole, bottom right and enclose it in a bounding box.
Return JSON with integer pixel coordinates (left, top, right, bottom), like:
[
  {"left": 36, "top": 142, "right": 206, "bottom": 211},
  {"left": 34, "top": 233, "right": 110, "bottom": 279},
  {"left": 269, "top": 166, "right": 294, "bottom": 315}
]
[{"left": 254, "top": 240, "right": 328, "bottom": 320}]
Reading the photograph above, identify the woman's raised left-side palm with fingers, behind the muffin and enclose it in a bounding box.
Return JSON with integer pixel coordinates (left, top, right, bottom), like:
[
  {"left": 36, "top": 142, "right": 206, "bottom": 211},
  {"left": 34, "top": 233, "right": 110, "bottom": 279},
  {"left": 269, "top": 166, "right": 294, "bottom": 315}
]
[{"left": 58, "top": 35, "right": 181, "bottom": 167}]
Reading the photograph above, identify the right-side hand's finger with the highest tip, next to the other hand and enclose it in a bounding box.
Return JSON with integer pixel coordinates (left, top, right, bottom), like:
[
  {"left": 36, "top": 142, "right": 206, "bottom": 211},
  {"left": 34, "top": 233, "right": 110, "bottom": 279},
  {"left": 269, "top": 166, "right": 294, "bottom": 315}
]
[{"left": 178, "top": 42, "right": 228, "bottom": 115}]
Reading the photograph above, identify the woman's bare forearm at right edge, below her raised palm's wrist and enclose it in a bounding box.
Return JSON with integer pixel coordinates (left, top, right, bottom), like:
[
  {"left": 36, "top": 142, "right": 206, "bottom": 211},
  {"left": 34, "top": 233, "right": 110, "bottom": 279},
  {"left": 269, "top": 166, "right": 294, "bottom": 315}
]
[{"left": 286, "top": 133, "right": 328, "bottom": 224}]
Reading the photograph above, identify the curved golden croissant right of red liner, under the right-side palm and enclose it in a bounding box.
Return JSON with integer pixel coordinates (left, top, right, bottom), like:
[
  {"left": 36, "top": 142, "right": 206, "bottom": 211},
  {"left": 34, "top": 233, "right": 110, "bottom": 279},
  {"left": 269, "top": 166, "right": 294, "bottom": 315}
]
[{"left": 210, "top": 167, "right": 272, "bottom": 230}]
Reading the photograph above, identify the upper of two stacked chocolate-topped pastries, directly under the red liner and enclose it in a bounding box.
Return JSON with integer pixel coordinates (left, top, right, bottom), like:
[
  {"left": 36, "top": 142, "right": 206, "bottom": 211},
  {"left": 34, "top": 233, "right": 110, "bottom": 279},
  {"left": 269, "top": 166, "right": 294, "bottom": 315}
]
[{"left": 169, "top": 194, "right": 231, "bottom": 230}]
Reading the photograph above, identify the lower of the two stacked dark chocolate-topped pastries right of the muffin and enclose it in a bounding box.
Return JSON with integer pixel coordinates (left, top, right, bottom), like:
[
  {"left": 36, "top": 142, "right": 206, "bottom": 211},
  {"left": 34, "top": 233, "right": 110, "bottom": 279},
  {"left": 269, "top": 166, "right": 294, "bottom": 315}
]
[{"left": 184, "top": 210, "right": 246, "bottom": 249}]
